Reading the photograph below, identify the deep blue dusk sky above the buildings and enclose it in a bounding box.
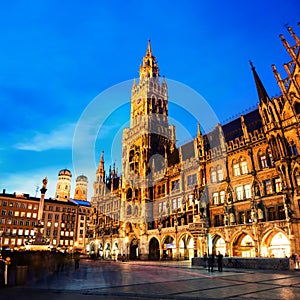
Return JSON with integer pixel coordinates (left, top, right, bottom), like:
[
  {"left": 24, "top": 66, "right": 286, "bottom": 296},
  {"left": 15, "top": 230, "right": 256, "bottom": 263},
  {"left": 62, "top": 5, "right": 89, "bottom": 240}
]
[{"left": 0, "top": 0, "right": 300, "bottom": 197}]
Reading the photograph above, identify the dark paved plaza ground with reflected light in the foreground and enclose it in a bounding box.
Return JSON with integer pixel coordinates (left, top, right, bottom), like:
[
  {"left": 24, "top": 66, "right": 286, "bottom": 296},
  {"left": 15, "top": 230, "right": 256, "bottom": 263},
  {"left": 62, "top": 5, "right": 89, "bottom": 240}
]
[{"left": 0, "top": 260, "right": 300, "bottom": 300}]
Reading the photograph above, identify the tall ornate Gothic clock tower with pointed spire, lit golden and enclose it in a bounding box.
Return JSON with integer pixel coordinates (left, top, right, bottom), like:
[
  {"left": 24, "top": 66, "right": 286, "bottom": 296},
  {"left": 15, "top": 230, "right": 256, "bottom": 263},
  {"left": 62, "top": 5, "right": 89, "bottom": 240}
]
[{"left": 120, "top": 41, "right": 176, "bottom": 258}]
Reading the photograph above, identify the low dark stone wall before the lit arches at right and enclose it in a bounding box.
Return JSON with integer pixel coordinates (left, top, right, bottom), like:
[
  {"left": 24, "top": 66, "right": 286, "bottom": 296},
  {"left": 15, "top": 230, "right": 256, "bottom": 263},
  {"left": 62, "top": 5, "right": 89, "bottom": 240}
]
[{"left": 192, "top": 257, "right": 294, "bottom": 270}]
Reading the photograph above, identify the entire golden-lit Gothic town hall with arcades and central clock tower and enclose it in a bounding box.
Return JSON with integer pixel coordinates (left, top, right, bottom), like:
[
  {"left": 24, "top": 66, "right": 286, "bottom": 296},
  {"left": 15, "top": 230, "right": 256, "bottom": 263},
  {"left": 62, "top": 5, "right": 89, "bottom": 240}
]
[{"left": 88, "top": 27, "right": 300, "bottom": 260}]
